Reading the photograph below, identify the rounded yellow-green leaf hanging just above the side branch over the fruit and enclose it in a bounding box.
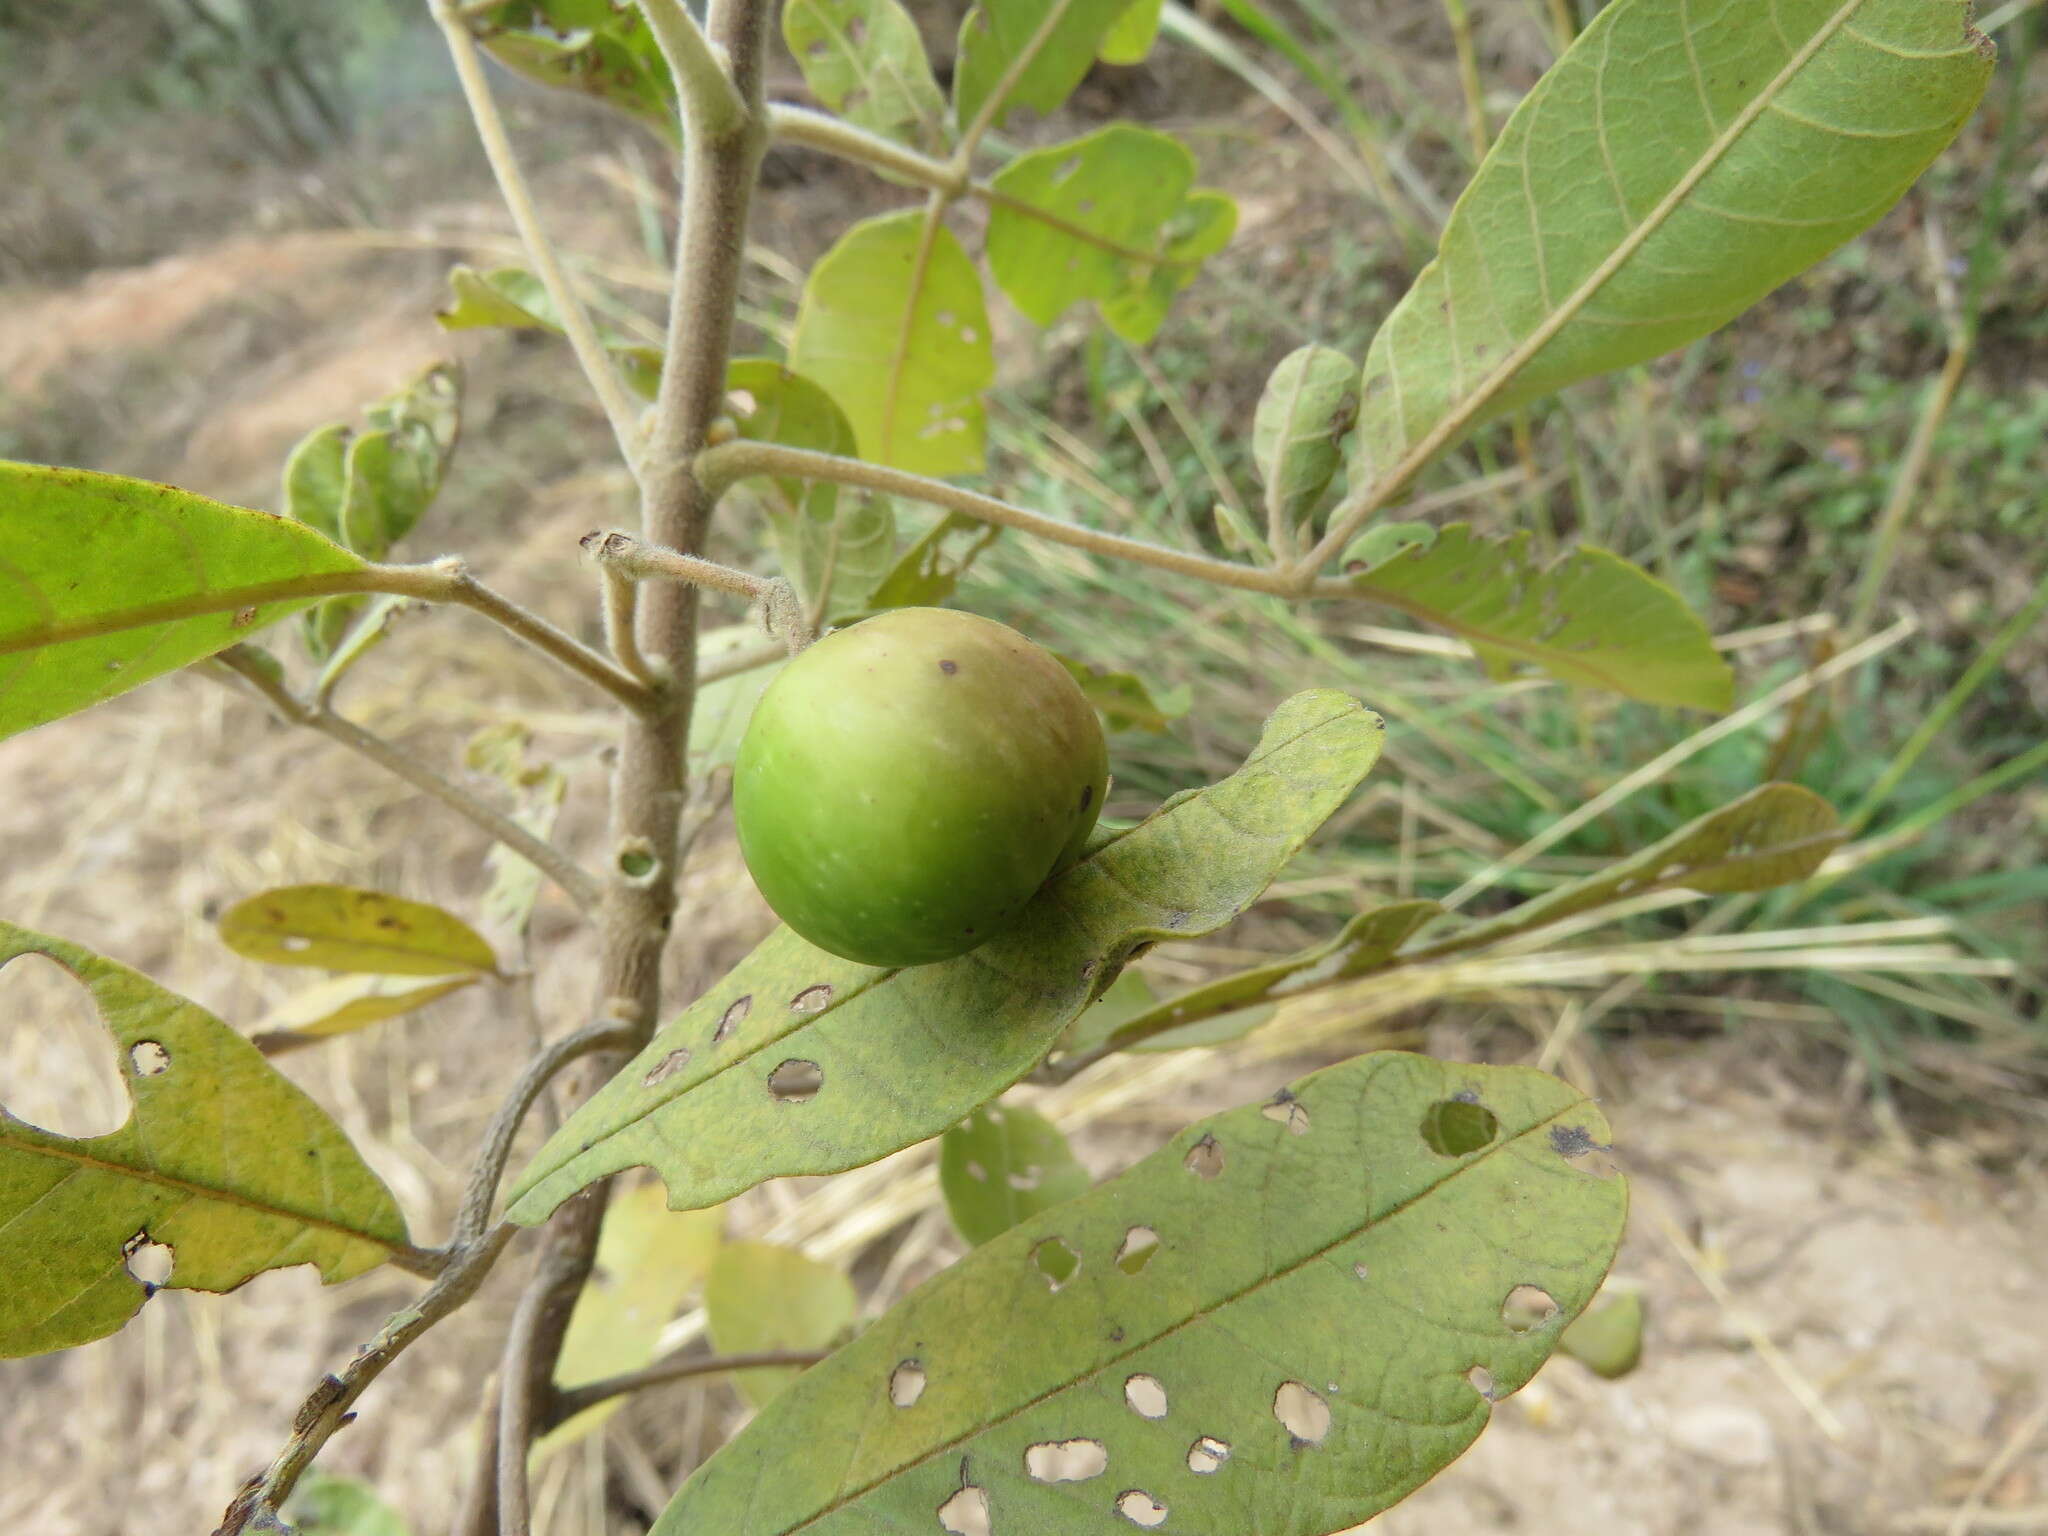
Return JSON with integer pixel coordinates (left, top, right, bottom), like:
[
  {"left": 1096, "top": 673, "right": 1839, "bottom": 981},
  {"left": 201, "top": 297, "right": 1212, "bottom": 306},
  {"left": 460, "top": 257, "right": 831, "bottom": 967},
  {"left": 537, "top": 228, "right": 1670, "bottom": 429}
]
[{"left": 788, "top": 213, "right": 995, "bottom": 475}]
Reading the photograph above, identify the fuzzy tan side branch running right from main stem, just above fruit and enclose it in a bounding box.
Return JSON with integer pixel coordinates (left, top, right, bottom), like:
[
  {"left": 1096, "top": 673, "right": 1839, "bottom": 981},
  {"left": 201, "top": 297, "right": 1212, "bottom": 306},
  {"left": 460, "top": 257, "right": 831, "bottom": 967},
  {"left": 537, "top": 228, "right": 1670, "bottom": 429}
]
[{"left": 698, "top": 440, "right": 1318, "bottom": 598}]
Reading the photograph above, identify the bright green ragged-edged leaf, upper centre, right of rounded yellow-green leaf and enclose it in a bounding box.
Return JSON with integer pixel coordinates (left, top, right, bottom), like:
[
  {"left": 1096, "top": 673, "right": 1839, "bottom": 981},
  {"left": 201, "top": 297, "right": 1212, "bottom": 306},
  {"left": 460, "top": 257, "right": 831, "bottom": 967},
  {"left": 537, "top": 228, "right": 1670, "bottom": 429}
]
[{"left": 987, "top": 123, "right": 1228, "bottom": 344}]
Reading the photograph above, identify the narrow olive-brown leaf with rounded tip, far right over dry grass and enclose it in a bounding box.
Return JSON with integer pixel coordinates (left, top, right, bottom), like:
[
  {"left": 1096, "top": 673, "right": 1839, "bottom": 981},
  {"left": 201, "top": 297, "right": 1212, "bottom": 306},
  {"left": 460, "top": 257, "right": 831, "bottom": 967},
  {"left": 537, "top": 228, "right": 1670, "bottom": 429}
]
[{"left": 1427, "top": 784, "right": 1845, "bottom": 954}]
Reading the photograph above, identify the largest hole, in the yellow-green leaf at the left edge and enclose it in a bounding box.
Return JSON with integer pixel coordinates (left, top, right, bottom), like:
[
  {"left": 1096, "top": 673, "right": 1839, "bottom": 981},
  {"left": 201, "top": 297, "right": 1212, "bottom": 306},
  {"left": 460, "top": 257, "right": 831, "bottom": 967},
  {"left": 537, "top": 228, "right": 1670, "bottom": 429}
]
[{"left": 0, "top": 954, "right": 129, "bottom": 1139}]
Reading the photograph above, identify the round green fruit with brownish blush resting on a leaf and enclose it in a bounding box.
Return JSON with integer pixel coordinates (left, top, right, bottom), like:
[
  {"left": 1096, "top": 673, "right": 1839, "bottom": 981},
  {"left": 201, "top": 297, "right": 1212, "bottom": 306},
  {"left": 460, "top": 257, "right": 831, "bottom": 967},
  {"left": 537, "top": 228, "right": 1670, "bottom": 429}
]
[{"left": 733, "top": 608, "right": 1108, "bottom": 967}]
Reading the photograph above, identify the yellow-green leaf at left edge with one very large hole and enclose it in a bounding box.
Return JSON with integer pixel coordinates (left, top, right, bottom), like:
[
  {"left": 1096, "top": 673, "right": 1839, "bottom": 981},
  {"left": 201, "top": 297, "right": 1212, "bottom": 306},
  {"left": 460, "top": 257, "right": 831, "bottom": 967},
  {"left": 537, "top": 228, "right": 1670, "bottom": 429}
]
[{"left": 0, "top": 924, "right": 408, "bottom": 1356}]
